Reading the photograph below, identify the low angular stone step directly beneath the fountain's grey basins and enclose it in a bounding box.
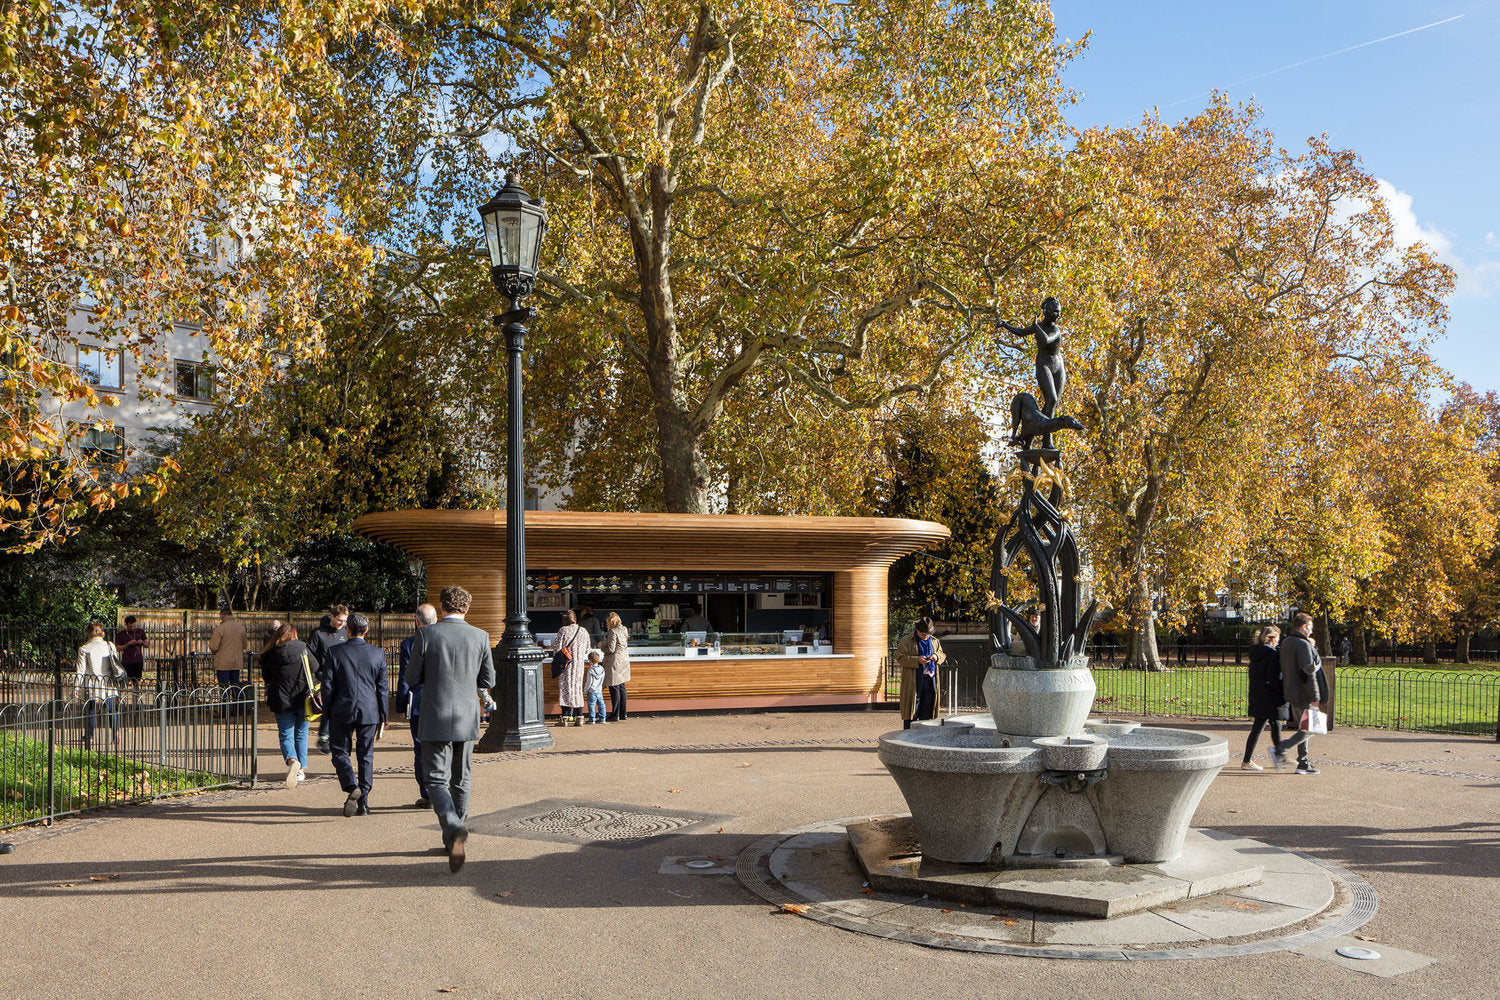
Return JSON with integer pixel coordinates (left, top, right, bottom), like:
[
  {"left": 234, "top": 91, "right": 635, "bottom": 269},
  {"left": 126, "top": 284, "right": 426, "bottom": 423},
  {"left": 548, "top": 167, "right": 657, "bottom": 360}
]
[{"left": 846, "top": 816, "right": 1265, "bottom": 919}]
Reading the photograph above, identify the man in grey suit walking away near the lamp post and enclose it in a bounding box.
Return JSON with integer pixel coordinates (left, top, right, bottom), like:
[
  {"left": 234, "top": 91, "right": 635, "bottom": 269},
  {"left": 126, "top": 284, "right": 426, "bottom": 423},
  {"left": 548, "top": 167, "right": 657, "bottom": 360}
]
[{"left": 407, "top": 586, "right": 495, "bottom": 871}]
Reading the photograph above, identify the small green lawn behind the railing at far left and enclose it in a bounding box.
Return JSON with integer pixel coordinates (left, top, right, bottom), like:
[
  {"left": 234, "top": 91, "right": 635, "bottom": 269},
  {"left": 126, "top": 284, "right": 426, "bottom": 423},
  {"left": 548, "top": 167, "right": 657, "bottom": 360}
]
[{"left": 0, "top": 732, "right": 222, "bottom": 828}]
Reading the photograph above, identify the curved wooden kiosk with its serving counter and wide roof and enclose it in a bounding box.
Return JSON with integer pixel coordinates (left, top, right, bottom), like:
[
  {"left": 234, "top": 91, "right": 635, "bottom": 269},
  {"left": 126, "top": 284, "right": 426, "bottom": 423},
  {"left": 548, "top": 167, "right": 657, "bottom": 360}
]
[{"left": 354, "top": 510, "right": 950, "bottom": 711}]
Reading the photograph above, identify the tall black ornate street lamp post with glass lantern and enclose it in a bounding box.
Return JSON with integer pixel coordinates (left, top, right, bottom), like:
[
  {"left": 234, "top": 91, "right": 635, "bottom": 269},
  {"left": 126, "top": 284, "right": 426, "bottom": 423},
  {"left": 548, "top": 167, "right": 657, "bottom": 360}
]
[{"left": 479, "top": 174, "right": 552, "bottom": 753}]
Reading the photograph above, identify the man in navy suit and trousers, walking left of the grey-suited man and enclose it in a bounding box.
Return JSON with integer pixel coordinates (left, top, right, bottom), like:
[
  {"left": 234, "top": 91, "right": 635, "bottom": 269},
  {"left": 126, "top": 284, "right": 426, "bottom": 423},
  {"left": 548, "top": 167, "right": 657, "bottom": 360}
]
[{"left": 323, "top": 612, "right": 390, "bottom": 816}]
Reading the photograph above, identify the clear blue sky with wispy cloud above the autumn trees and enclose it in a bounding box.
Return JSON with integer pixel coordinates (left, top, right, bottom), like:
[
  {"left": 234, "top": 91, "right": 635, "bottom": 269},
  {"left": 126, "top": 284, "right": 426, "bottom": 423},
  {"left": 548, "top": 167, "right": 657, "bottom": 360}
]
[{"left": 1053, "top": 0, "right": 1500, "bottom": 391}]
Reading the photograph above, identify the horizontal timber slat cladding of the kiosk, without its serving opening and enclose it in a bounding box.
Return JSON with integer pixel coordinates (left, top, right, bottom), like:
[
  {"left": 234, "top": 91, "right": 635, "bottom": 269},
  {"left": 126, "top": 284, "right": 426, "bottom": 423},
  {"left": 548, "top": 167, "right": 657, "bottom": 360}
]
[{"left": 354, "top": 510, "right": 950, "bottom": 703}]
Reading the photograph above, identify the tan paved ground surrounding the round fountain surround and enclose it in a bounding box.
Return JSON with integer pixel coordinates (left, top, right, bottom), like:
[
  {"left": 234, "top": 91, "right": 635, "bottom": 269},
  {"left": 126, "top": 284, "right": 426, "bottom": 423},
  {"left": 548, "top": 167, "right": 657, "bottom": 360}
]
[{"left": 0, "top": 712, "right": 1500, "bottom": 1000}]
